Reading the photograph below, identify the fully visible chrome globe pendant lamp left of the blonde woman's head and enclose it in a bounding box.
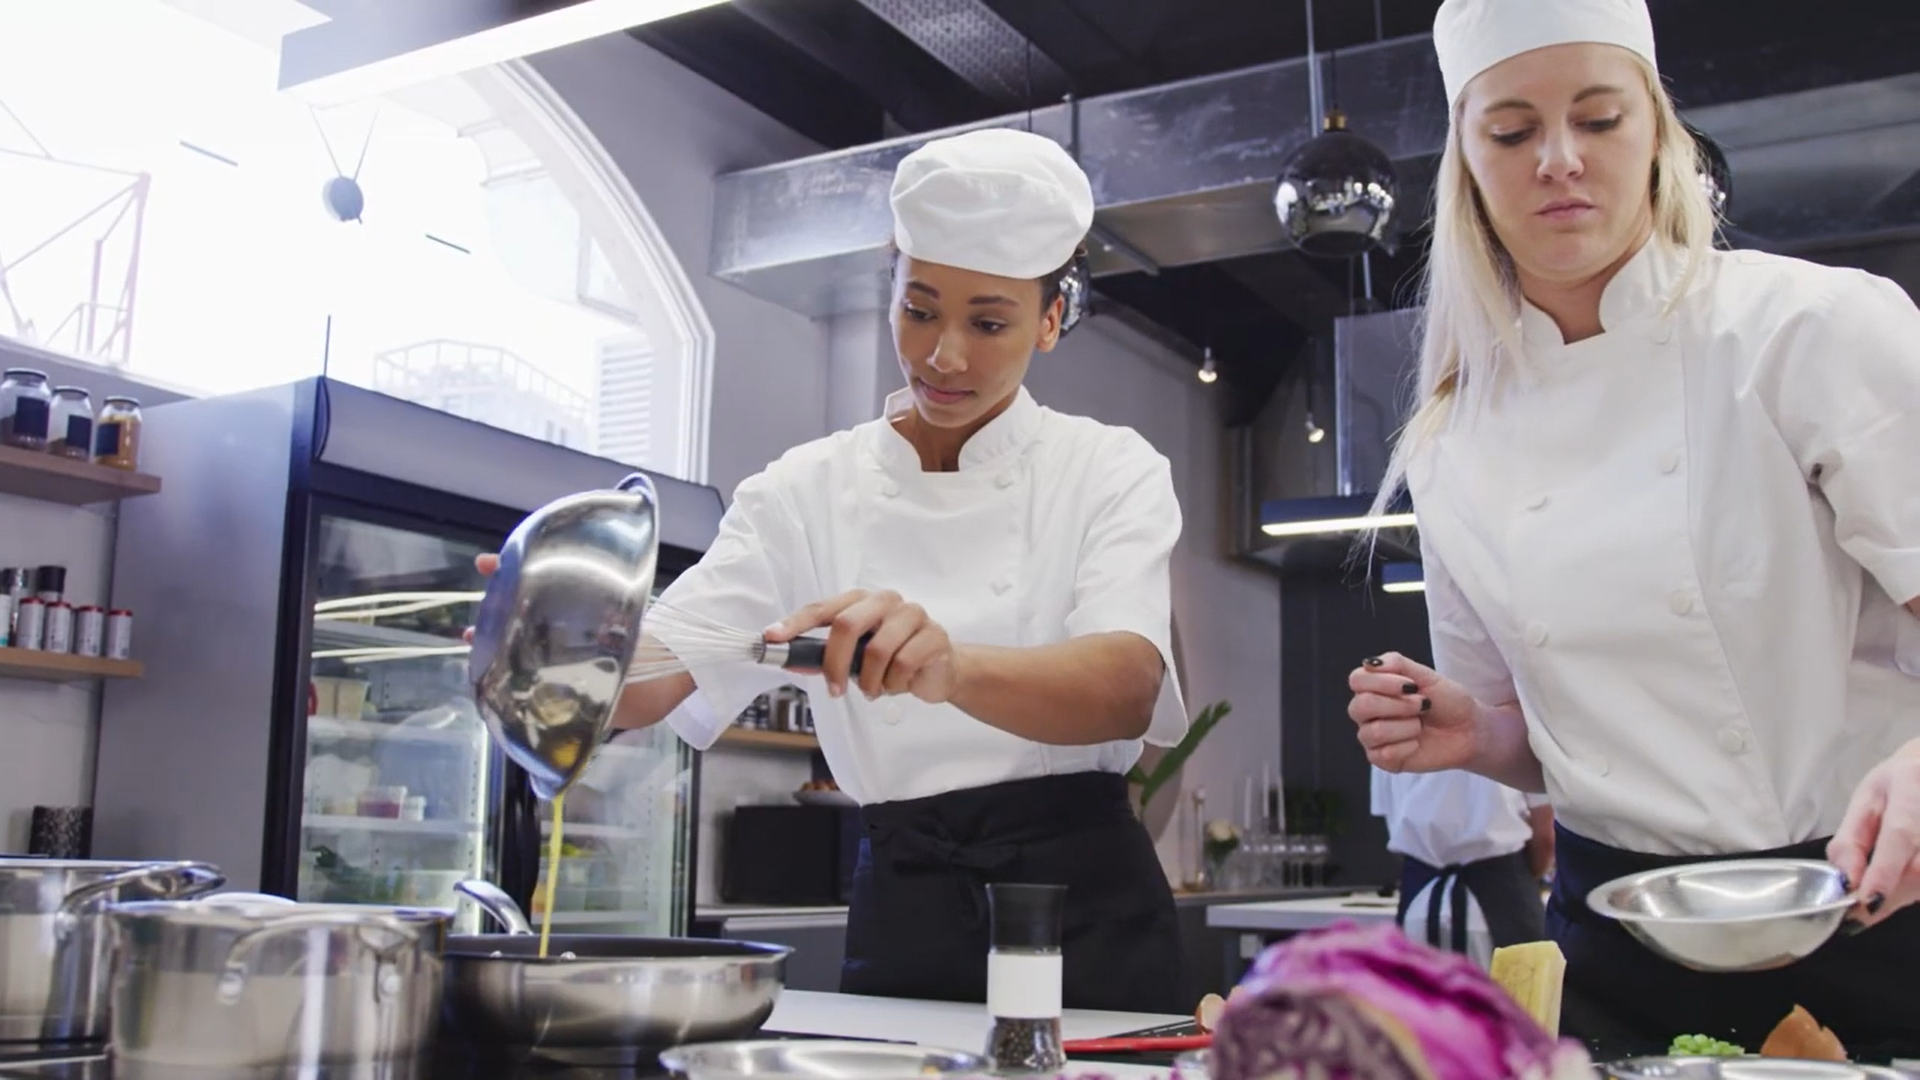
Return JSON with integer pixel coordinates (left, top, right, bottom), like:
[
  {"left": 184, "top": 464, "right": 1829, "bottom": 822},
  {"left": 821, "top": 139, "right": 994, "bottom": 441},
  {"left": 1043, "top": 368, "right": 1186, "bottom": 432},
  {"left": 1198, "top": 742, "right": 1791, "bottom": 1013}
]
[{"left": 1273, "top": 0, "right": 1400, "bottom": 259}]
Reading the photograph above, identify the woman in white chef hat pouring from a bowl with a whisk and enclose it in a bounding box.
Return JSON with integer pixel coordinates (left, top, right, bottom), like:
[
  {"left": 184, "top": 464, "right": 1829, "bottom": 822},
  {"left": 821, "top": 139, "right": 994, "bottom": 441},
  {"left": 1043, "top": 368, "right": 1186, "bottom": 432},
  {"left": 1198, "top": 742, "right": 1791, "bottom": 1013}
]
[{"left": 583, "top": 129, "right": 1192, "bottom": 1015}]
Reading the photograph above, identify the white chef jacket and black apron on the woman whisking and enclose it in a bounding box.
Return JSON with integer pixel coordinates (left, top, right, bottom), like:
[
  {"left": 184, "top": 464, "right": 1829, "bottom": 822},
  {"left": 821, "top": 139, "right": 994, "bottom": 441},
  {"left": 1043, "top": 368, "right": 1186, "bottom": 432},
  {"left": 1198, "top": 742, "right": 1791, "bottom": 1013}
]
[{"left": 662, "top": 382, "right": 1190, "bottom": 1013}]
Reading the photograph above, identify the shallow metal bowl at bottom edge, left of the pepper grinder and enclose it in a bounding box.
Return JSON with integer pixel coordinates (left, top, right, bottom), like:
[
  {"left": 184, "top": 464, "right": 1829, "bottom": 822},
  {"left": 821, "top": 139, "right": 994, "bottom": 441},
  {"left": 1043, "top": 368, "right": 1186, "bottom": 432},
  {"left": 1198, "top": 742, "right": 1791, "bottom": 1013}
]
[{"left": 660, "top": 1040, "right": 993, "bottom": 1080}]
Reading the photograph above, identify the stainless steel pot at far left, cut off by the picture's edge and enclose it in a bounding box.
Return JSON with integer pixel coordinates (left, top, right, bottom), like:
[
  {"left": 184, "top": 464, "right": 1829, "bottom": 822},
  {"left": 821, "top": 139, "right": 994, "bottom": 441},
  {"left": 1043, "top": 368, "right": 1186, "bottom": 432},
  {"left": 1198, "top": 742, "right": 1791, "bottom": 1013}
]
[{"left": 0, "top": 859, "right": 225, "bottom": 1045}]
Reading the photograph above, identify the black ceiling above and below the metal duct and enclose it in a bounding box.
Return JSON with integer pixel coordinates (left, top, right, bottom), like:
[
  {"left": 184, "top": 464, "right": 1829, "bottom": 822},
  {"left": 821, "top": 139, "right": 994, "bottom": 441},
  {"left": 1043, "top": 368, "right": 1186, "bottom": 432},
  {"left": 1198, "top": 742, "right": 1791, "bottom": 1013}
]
[{"left": 634, "top": 0, "right": 1920, "bottom": 423}]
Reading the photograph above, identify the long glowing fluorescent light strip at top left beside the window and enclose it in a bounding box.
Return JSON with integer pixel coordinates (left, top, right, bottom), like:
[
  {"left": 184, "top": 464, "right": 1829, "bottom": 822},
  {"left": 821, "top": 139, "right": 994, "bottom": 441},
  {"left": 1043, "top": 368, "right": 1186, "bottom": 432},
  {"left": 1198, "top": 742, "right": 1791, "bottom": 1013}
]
[{"left": 288, "top": 0, "right": 726, "bottom": 108}]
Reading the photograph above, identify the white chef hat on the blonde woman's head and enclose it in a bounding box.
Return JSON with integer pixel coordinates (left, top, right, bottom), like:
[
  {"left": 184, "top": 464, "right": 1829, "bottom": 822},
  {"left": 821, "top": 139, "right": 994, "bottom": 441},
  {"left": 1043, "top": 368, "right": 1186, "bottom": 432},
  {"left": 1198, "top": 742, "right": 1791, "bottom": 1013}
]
[{"left": 1434, "top": 0, "right": 1659, "bottom": 104}]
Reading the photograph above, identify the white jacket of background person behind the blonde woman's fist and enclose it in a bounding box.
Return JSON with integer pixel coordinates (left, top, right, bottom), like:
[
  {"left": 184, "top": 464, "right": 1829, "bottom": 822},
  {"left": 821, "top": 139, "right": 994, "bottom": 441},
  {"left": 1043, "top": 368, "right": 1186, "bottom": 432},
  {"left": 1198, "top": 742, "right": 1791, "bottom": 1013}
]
[{"left": 1373, "top": 769, "right": 1546, "bottom": 867}]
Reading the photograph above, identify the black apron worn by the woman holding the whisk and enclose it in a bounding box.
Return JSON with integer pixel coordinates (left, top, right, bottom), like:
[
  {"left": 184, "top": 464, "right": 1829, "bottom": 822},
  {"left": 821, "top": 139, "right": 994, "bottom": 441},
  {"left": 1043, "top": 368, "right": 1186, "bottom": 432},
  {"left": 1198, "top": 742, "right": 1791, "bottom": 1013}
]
[{"left": 841, "top": 773, "right": 1194, "bottom": 1015}]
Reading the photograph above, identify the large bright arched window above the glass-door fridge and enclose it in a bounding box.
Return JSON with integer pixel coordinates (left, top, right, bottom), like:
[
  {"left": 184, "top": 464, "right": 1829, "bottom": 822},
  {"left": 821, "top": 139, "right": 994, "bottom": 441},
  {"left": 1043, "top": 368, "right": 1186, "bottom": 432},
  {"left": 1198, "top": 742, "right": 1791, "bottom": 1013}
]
[{"left": 0, "top": 0, "right": 712, "bottom": 480}]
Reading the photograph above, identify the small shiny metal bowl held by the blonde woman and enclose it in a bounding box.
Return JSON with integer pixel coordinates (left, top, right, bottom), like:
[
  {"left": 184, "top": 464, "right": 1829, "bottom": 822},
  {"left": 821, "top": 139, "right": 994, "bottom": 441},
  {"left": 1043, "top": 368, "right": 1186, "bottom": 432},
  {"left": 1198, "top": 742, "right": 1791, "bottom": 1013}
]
[{"left": 1586, "top": 859, "right": 1855, "bottom": 972}]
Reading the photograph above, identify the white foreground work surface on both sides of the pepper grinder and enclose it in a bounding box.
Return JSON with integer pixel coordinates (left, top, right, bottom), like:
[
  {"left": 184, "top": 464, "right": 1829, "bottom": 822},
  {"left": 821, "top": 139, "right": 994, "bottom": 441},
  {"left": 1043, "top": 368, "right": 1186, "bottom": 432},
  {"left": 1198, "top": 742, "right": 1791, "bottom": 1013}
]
[{"left": 764, "top": 990, "right": 1198, "bottom": 1080}]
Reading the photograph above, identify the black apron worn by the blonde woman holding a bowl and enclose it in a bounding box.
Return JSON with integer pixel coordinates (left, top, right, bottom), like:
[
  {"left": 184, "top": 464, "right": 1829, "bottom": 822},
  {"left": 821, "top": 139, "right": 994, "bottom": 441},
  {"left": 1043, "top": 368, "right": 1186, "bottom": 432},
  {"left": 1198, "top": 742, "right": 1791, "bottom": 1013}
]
[{"left": 1548, "top": 826, "right": 1920, "bottom": 1061}]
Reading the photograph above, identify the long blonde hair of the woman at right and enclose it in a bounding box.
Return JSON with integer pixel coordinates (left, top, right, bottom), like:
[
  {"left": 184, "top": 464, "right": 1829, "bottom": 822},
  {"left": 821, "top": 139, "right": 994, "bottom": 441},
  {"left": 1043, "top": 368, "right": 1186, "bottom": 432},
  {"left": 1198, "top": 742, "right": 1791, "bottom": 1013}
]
[{"left": 1373, "top": 56, "right": 1718, "bottom": 515}]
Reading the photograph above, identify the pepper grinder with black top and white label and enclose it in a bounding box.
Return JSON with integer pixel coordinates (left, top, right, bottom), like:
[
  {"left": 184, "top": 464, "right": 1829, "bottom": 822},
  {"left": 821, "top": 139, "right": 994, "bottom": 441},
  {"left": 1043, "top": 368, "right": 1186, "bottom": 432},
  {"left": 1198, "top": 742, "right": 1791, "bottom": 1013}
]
[{"left": 987, "top": 884, "right": 1068, "bottom": 1074}]
